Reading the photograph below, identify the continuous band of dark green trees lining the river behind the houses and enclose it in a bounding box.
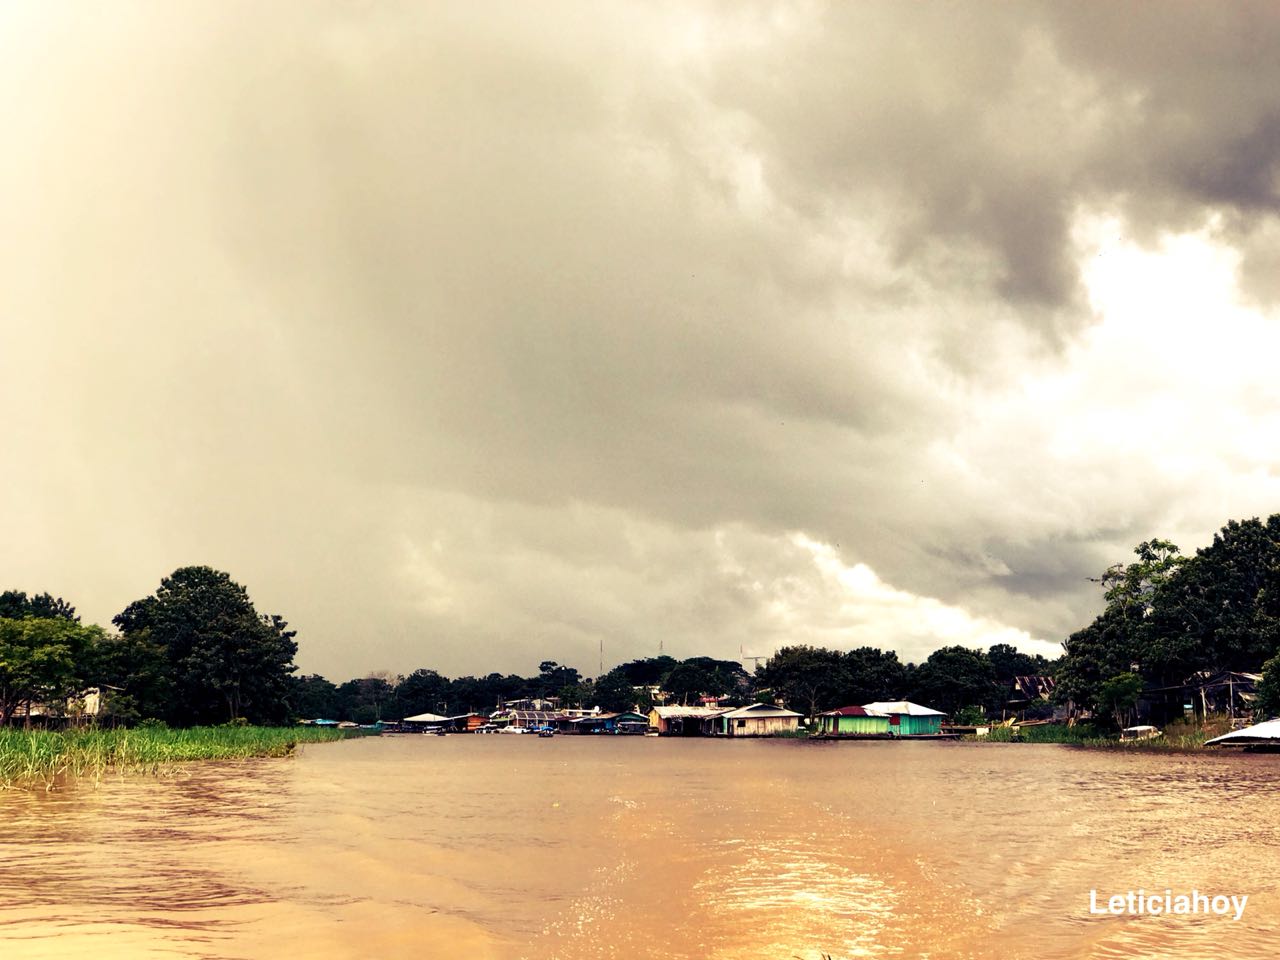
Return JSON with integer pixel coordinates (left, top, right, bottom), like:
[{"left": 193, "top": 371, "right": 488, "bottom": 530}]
[{"left": 0, "top": 516, "right": 1280, "bottom": 737}]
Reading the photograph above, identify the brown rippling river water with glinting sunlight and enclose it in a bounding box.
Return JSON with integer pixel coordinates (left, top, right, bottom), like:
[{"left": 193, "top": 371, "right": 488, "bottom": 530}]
[{"left": 0, "top": 736, "right": 1280, "bottom": 960}]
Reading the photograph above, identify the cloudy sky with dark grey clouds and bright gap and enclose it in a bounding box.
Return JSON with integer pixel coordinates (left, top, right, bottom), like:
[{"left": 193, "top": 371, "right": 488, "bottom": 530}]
[{"left": 0, "top": 0, "right": 1280, "bottom": 681}]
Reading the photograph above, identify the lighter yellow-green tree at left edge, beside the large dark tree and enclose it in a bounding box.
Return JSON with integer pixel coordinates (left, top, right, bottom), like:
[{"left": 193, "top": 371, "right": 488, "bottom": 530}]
[{"left": 0, "top": 617, "right": 102, "bottom": 726}]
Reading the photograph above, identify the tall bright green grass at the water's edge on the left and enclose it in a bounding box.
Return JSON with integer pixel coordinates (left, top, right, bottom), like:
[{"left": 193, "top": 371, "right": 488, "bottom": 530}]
[{"left": 0, "top": 726, "right": 346, "bottom": 790}]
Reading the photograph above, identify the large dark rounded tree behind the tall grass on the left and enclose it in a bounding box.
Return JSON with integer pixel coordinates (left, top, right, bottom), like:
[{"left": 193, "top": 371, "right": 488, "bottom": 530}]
[{"left": 114, "top": 567, "right": 298, "bottom": 723}]
